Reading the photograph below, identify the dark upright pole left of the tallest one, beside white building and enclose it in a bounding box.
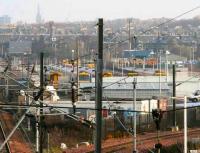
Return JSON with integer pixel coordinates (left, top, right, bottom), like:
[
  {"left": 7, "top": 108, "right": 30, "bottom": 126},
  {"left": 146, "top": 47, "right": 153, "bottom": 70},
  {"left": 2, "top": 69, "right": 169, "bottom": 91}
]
[{"left": 39, "top": 53, "right": 44, "bottom": 153}]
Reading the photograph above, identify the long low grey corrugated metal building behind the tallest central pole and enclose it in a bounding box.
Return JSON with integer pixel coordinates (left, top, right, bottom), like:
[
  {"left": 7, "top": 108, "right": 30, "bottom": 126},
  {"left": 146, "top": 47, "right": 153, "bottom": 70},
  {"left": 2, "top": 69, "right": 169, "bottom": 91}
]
[{"left": 80, "top": 82, "right": 170, "bottom": 100}]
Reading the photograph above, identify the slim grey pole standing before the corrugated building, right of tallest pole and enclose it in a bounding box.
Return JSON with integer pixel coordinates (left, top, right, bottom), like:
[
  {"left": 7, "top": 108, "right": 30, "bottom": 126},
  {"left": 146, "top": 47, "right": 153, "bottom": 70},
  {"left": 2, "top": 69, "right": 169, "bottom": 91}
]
[{"left": 133, "top": 78, "right": 137, "bottom": 153}]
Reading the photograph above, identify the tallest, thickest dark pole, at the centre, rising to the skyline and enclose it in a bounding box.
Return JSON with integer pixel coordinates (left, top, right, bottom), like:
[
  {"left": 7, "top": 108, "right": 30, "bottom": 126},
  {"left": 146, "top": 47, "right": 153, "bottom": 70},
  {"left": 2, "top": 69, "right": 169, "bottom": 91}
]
[{"left": 95, "top": 18, "right": 103, "bottom": 153}]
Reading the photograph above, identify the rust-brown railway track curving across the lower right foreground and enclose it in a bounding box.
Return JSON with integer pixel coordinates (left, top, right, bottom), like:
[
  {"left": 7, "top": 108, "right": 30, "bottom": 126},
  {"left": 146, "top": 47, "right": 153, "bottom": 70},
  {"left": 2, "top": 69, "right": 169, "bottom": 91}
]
[{"left": 64, "top": 128, "right": 200, "bottom": 153}]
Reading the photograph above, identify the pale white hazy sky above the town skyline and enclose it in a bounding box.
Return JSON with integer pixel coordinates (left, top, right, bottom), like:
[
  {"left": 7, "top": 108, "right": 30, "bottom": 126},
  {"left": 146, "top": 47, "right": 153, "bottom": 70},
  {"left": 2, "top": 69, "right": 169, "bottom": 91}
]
[{"left": 0, "top": 0, "right": 200, "bottom": 23}]
